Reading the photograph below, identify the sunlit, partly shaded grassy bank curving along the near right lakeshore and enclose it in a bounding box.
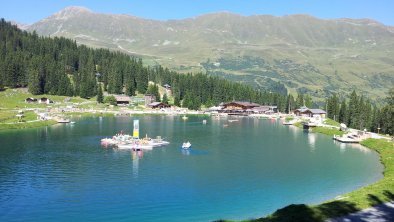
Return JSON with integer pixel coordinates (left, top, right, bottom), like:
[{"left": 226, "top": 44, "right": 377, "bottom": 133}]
[{"left": 220, "top": 139, "right": 394, "bottom": 222}]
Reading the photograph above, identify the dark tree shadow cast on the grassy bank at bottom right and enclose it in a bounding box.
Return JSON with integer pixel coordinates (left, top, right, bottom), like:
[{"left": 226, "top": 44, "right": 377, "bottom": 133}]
[{"left": 214, "top": 190, "right": 394, "bottom": 222}]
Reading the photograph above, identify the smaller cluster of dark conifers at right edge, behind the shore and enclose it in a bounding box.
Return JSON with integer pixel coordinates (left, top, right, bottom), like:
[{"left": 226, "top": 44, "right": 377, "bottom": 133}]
[{"left": 326, "top": 88, "right": 394, "bottom": 135}]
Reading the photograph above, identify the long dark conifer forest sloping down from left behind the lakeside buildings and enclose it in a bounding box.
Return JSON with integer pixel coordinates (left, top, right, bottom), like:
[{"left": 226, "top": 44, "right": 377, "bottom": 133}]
[{"left": 0, "top": 19, "right": 294, "bottom": 112}]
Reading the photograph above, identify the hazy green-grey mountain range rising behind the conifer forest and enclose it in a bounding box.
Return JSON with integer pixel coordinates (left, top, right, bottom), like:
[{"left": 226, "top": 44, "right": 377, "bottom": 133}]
[{"left": 28, "top": 7, "right": 394, "bottom": 99}]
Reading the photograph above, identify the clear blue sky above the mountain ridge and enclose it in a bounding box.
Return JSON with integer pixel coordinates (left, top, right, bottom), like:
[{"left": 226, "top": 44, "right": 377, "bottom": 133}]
[{"left": 0, "top": 0, "right": 394, "bottom": 26}]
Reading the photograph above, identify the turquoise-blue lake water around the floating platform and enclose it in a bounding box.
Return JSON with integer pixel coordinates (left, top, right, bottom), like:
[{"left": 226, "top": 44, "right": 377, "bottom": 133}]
[{"left": 0, "top": 116, "right": 383, "bottom": 221}]
